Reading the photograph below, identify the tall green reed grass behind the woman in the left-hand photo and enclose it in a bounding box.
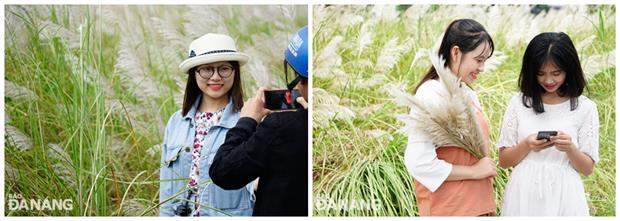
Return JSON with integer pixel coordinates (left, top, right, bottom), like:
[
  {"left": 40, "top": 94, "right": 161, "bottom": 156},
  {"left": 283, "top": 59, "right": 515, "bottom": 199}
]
[{"left": 3, "top": 5, "right": 307, "bottom": 216}]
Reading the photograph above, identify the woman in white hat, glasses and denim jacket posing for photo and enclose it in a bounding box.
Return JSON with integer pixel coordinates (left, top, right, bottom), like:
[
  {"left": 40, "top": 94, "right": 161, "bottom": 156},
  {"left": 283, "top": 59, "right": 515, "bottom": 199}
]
[{"left": 159, "top": 33, "right": 253, "bottom": 216}]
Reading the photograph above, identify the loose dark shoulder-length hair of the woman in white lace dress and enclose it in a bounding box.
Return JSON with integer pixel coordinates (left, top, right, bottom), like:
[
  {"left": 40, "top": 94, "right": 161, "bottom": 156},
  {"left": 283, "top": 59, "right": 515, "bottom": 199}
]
[{"left": 519, "top": 32, "right": 586, "bottom": 114}]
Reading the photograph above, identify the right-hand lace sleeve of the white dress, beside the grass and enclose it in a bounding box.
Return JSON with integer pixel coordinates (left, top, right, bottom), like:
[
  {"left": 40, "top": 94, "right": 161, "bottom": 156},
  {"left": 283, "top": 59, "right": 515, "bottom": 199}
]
[{"left": 577, "top": 100, "right": 599, "bottom": 163}]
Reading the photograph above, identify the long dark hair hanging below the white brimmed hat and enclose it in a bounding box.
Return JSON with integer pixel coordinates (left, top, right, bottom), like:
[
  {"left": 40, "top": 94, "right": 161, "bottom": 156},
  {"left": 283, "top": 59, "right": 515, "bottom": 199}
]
[{"left": 181, "top": 61, "right": 243, "bottom": 116}]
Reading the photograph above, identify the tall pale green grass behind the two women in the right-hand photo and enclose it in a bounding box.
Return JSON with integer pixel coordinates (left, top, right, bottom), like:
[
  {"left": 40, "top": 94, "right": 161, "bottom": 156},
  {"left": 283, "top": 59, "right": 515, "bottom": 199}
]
[{"left": 312, "top": 5, "right": 616, "bottom": 216}]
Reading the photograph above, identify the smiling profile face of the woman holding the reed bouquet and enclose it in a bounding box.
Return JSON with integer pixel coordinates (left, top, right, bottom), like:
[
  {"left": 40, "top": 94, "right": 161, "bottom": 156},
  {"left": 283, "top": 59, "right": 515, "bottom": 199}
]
[{"left": 450, "top": 42, "right": 491, "bottom": 85}]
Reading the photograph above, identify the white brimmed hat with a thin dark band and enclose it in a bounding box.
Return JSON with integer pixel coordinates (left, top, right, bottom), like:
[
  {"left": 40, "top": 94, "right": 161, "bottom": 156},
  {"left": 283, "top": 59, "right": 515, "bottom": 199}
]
[{"left": 179, "top": 33, "right": 250, "bottom": 73}]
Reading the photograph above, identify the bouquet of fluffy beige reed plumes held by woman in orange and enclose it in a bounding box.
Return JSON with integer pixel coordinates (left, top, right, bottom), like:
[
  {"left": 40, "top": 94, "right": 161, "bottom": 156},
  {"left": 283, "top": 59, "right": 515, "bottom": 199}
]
[{"left": 392, "top": 52, "right": 486, "bottom": 159}]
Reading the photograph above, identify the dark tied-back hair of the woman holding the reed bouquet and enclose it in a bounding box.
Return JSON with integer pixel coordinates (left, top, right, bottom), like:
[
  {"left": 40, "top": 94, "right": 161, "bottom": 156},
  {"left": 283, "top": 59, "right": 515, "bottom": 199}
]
[{"left": 414, "top": 19, "right": 495, "bottom": 92}]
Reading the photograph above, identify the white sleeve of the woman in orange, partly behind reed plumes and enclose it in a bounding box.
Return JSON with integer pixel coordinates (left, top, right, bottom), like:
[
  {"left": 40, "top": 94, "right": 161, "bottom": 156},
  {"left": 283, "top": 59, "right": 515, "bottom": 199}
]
[{"left": 404, "top": 81, "right": 452, "bottom": 192}]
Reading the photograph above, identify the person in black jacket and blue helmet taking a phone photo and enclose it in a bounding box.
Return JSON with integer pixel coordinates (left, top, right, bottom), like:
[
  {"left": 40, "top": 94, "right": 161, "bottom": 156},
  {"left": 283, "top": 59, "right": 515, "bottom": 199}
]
[{"left": 209, "top": 27, "right": 309, "bottom": 216}]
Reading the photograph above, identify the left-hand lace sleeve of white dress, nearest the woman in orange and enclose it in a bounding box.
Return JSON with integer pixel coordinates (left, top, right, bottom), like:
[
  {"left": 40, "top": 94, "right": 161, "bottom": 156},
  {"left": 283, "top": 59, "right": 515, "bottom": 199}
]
[{"left": 497, "top": 94, "right": 522, "bottom": 148}]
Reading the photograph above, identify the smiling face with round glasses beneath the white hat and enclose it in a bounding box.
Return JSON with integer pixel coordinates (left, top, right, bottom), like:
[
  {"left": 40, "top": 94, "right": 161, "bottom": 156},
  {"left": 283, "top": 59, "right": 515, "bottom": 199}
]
[{"left": 195, "top": 61, "right": 237, "bottom": 99}]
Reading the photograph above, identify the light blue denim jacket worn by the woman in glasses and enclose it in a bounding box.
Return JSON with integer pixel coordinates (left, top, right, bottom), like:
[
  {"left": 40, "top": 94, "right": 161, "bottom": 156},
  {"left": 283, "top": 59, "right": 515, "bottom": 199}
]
[{"left": 159, "top": 96, "right": 254, "bottom": 216}]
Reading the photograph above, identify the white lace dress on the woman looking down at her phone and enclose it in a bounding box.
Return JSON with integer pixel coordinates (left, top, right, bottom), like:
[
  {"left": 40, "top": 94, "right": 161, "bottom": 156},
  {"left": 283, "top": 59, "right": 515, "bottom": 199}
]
[{"left": 497, "top": 93, "right": 599, "bottom": 216}]
